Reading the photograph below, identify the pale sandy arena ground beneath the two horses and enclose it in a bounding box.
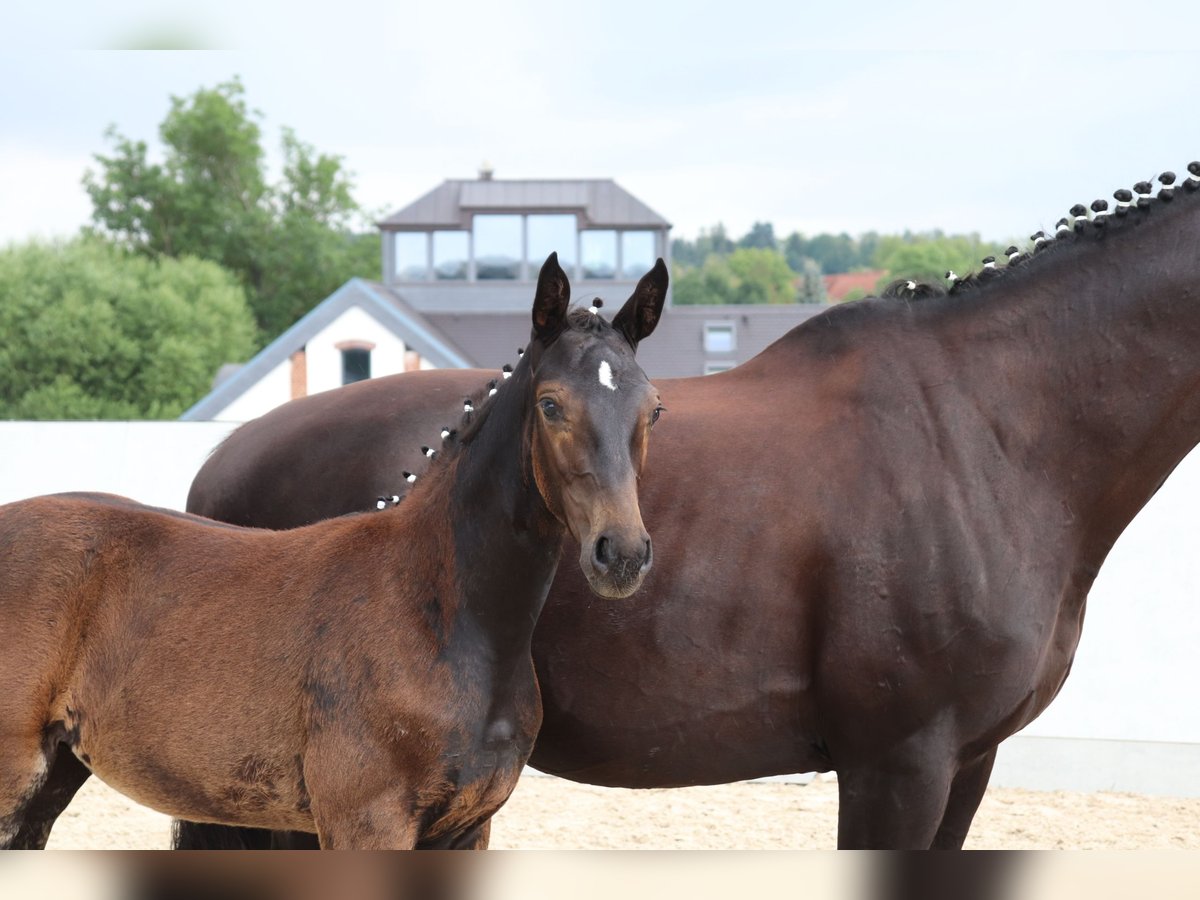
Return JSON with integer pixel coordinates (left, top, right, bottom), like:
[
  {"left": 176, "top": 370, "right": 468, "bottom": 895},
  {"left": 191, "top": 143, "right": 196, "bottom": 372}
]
[{"left": 42, "top": 776, "right": 1200, "bottom": 850}]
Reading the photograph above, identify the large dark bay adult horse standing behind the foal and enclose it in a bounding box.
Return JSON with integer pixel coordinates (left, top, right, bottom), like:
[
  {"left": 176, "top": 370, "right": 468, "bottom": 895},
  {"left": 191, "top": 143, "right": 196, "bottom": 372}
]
[{"left": 181, "top": 163, "right": 1200, "bottom": 847}]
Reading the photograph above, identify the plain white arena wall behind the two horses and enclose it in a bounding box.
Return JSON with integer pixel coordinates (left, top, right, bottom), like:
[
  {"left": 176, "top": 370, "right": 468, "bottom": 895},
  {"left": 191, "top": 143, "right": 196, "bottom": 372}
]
[{"left": 0, "top": 422, "right": 1200, "bottom": 796}]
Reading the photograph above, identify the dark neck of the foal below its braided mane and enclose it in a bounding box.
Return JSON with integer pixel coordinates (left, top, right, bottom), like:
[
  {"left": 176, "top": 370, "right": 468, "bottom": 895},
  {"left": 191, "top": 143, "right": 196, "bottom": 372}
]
[{"left": 406, "top": 365, "right": 564, "bottom": 665}]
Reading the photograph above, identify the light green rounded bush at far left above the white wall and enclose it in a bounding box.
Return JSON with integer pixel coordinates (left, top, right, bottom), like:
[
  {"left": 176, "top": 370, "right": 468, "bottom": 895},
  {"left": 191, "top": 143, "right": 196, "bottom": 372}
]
[{"left": 0, "top": 240, "right": 254, "bottom": 419}]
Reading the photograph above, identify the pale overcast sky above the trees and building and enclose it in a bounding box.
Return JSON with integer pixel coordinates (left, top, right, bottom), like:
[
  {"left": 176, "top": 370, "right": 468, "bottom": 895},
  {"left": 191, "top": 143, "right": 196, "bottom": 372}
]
[{"left": 0, "top": 0, "right": 1200, "bottom": 250}]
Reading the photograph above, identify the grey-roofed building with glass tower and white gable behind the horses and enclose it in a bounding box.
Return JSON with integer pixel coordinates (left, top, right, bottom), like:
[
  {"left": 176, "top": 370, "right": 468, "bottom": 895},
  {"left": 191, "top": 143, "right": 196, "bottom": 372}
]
[{"left": 181, "top": 175, "right": 822, "bottom": 421}]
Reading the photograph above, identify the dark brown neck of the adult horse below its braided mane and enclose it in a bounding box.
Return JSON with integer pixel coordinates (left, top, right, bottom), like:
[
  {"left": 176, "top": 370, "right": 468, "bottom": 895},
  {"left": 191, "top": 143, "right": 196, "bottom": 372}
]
[{"left": 948, "top": 205, "right": 1200, "bottom": 556}]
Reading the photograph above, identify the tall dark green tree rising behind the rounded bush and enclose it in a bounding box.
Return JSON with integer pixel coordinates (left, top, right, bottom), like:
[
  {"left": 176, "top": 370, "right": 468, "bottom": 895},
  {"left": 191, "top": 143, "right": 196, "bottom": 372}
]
[{"left": 84, "top": 79, "right": 379, "bottom": 342}]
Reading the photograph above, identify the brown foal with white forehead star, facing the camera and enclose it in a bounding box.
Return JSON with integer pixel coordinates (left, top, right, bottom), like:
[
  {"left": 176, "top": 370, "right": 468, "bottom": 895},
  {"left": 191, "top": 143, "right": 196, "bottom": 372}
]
[{"left": 0, "top": 254, "right": 667, "bottom": 848}]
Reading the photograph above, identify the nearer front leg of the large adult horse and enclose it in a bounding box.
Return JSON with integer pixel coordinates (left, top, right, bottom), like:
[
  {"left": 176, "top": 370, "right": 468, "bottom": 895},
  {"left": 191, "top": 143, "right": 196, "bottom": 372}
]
[{"left": 838, "top": 758, "right": 955, "bottom": 850}]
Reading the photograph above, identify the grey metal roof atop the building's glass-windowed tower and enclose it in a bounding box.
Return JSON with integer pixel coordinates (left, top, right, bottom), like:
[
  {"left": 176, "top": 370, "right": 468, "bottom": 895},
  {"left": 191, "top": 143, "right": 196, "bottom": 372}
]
[{"left": 378, "top": 178, "right": 671, "bottom": 230}]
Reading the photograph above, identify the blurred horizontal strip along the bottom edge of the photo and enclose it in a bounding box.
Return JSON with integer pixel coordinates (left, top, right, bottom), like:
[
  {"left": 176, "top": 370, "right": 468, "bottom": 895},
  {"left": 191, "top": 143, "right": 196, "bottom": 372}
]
[{"left": 0, "top": 851, "right": 1200, "bottom": 900}]
